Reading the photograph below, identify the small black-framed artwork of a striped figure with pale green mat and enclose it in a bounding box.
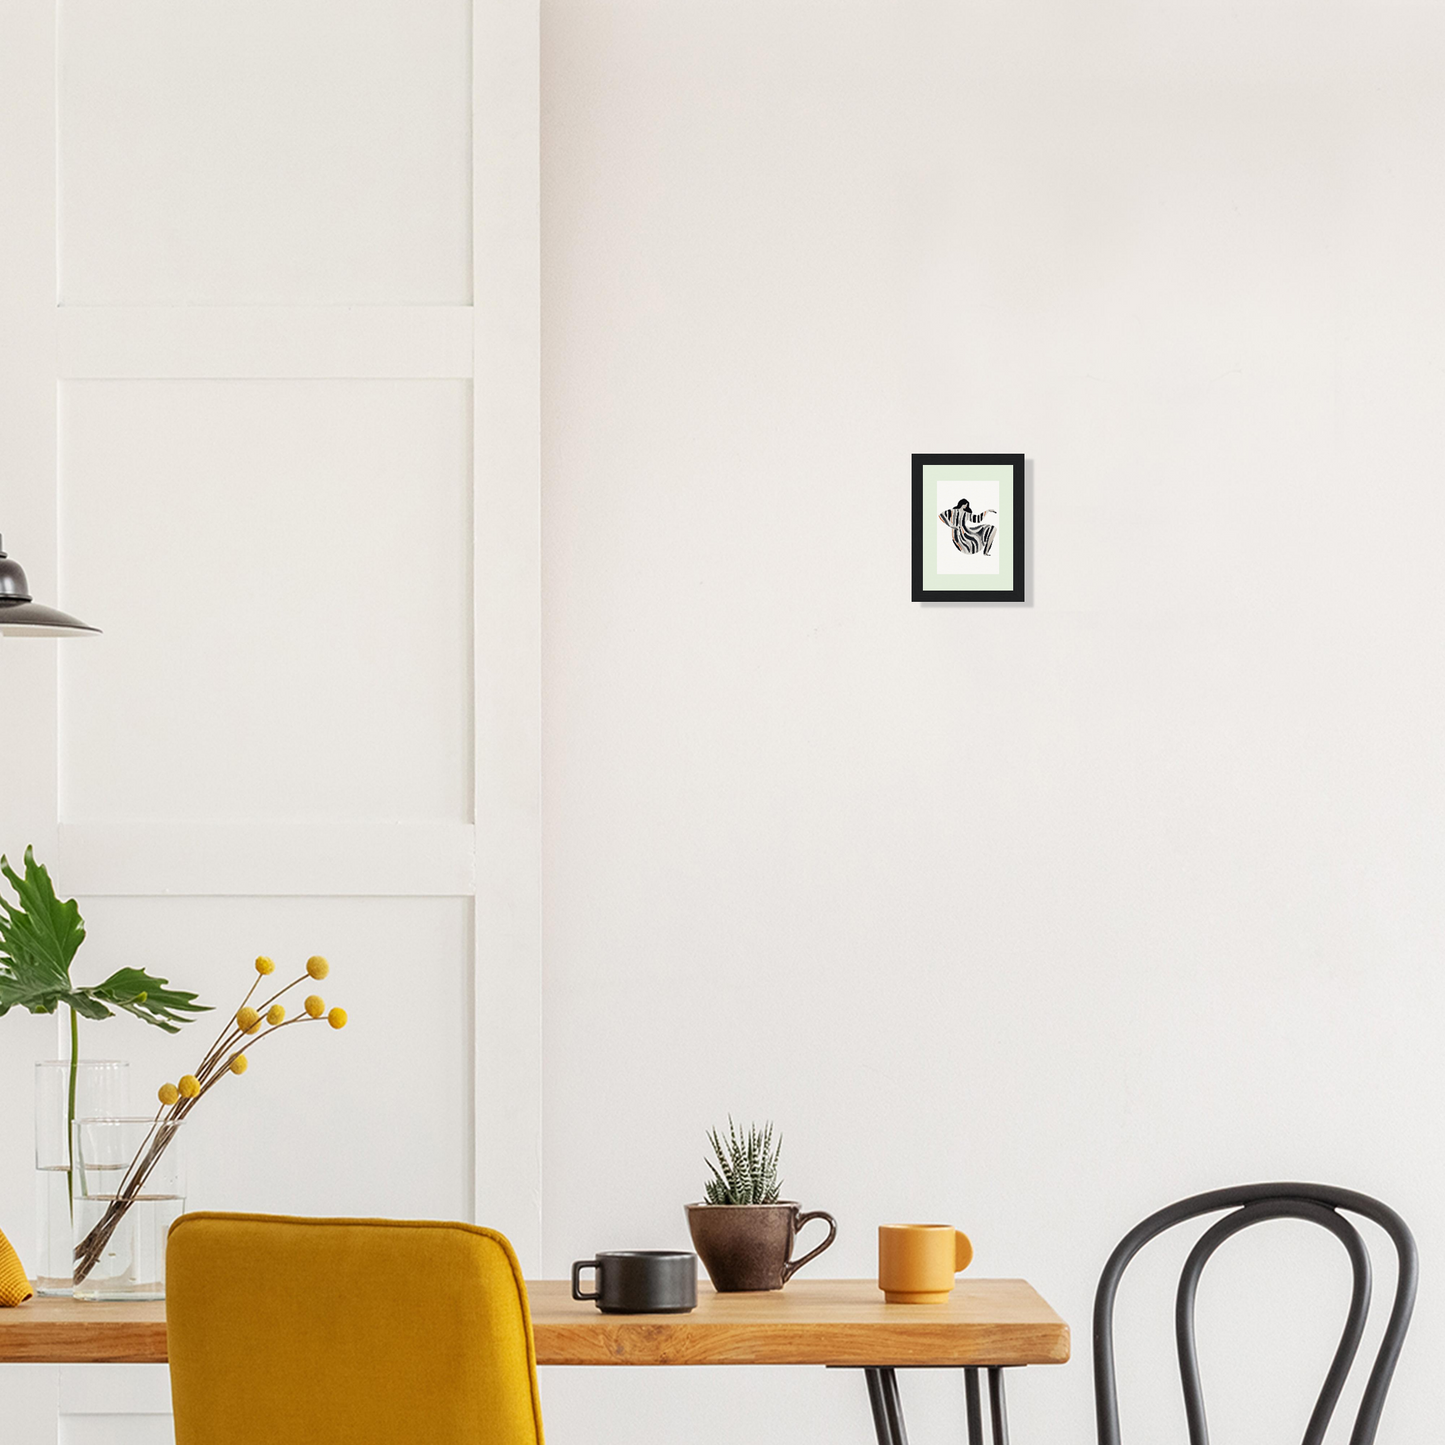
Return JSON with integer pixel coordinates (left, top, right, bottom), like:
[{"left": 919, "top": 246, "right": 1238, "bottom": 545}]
[{"left": 913, "top": 452, "right": 1025, "bottom": 603}]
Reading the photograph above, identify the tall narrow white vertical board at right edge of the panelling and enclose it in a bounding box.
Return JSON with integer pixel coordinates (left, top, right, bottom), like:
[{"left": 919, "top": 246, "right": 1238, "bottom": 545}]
[{"left": 473, "top": 0, "right": 542, "bottom": 1270}]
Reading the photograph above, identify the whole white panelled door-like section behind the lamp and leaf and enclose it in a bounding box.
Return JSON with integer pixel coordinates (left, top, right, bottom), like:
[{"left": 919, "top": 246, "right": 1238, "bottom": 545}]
[{"left": 0, "top": 0, "right": 540, "bottom": 1445}]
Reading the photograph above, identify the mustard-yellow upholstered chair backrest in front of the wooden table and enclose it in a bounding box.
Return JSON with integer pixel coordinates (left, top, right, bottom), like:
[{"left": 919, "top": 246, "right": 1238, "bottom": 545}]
[{"left": 166, "top": 1214, "right": 542, "bottom": 1445}]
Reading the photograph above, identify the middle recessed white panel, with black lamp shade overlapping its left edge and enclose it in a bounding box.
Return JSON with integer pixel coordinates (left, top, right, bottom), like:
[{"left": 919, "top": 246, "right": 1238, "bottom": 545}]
[{"left": 61, "top": 381, "right": 471, "bottom": 822}]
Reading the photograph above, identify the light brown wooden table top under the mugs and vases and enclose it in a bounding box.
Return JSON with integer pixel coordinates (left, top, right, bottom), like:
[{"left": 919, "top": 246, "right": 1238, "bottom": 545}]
[{"left": 0, "top": 1279, "right": 1069, "bottom": 1366}]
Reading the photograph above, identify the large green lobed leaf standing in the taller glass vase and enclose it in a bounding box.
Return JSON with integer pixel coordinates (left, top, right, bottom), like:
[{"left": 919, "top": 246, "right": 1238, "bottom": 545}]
[{"left": 0, "top": 848, "right": 207, "bottom": 1033}]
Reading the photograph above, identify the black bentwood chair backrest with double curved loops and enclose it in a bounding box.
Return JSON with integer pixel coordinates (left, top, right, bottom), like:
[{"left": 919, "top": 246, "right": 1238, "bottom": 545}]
[{"left": 1094, "top": 1183, "right": 1419, "bottom": 1445}]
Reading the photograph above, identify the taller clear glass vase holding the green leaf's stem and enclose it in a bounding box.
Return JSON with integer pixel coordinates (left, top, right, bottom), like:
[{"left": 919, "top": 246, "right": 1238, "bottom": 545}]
[{"left": 35, "top": 1059, "right": 130, "bottom": 1295}]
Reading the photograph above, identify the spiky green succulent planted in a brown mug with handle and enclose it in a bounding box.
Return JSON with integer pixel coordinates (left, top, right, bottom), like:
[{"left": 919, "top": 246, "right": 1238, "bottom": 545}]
[{"left": 686, "top": 1114, "right": 838, "bottom": 1293}]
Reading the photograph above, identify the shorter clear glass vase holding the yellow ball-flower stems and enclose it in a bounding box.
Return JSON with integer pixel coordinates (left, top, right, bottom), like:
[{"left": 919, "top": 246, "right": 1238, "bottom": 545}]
[{"left": 72, "top": 1117, "right": 185, "bottom": 1299}]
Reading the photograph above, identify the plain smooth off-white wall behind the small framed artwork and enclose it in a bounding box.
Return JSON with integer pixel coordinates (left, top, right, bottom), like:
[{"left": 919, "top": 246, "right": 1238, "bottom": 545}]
[{"left": 543, "top": 0, "right": 1445, "bottom": 1445}]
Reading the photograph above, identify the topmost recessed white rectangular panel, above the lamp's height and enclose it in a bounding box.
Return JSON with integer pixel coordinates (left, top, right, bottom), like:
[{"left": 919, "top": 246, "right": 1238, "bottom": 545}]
[{"left": 59, "top": 0, "right": 471, "bottom": 305}]
